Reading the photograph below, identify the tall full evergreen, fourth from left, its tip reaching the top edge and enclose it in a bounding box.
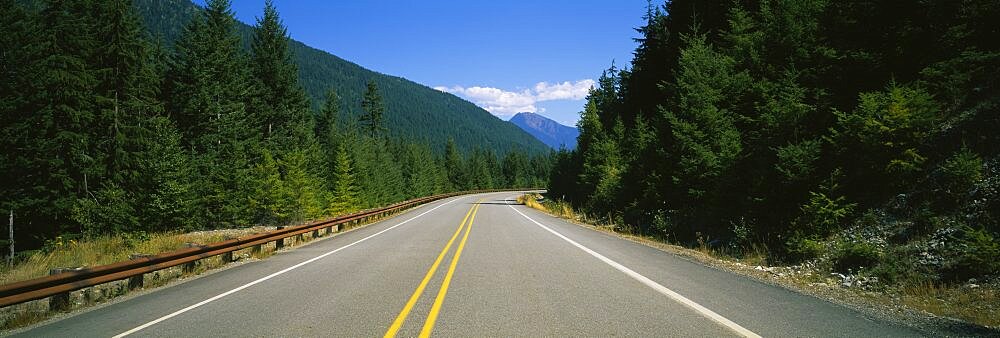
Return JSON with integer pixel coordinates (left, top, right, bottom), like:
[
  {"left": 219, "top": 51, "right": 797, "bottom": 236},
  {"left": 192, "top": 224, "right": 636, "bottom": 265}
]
[{"left": 166, "top": 0, "right": 260, "bottom": 226}]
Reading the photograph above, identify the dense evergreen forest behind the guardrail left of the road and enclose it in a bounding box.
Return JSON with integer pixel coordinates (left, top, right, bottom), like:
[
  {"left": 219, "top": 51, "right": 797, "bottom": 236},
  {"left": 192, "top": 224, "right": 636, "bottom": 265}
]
[{"left": 0, "top": 0, "right": 552, "bottom": 250}]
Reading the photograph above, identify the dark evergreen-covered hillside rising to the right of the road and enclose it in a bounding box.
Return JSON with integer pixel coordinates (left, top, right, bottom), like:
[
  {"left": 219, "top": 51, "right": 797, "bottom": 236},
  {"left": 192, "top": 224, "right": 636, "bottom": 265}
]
[{"left": 549, "top": 0, "right": 1000, "bottom": 283}]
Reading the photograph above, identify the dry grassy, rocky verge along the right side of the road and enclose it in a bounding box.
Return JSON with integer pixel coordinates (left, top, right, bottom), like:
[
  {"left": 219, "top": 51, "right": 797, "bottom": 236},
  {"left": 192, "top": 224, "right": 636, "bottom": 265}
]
[{"left": 517, "top": 194, "right": 1000, "bottom": 329}]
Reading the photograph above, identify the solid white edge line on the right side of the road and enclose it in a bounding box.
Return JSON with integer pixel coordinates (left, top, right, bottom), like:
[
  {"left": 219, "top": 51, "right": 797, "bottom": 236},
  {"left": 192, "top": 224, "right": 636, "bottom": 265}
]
[{"left": 506, "top": 198, "right": 760, "bottom": 338}]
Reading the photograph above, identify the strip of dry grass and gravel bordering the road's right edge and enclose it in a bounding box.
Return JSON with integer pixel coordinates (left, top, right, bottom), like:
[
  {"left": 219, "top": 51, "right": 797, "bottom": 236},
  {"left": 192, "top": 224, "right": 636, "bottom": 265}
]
[{"left": 517, "top": 194, "right": 1000, "bottom": 332}]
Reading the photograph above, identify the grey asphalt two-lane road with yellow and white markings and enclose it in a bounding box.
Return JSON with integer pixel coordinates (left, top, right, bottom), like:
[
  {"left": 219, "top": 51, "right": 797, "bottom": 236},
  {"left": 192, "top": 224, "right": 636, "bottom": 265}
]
[{"left": 19, "top": 192, "right": 921, "bottom": 337}]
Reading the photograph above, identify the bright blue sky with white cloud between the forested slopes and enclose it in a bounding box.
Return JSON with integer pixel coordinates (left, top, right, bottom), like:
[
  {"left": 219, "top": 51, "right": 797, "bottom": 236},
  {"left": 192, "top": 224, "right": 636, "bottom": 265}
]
[{"left": 196, "top": 0, "right": 646, "bottom": 125}]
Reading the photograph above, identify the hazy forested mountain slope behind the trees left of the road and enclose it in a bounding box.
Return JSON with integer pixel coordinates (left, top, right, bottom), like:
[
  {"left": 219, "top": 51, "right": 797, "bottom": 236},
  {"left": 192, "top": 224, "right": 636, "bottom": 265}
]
[{"left": 133, "top": 0, "right": 548, "bottom": 154}]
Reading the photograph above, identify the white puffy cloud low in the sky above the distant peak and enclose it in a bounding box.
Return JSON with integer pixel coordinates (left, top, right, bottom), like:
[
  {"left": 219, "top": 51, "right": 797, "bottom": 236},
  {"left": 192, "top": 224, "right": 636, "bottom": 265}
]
[{"left": 434, "top": 79, "right": 595, "bottom": 116}]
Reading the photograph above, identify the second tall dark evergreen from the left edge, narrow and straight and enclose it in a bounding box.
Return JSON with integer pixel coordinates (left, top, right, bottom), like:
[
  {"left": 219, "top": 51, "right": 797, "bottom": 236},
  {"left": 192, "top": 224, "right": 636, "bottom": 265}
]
[{"left": 33, "top": 1, "right": 105, "bottom": 231}]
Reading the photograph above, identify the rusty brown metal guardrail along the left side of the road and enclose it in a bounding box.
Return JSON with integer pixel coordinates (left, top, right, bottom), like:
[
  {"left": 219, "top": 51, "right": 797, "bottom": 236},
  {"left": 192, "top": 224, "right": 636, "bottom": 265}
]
[{"left": 0, "top": 189, "right": 537, "bottom": 307}]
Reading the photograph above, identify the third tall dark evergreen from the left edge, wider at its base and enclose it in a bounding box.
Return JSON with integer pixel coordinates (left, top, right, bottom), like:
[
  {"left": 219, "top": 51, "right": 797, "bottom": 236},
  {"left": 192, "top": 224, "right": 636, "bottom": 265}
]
[{"left": 74, "top": 0, "right": 186, "bottom": 233}]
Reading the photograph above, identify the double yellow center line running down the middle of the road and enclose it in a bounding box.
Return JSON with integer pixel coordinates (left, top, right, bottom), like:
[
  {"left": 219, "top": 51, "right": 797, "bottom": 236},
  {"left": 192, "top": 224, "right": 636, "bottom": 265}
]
[{"left": 385, "top": 199, "right": 483, "bottom": 338}]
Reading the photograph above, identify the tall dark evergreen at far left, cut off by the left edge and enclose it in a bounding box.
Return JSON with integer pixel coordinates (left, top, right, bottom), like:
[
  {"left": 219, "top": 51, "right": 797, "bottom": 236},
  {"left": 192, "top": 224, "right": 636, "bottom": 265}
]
[{"left": 0, "top": 0, "right": 69, "bottom": 245}]
